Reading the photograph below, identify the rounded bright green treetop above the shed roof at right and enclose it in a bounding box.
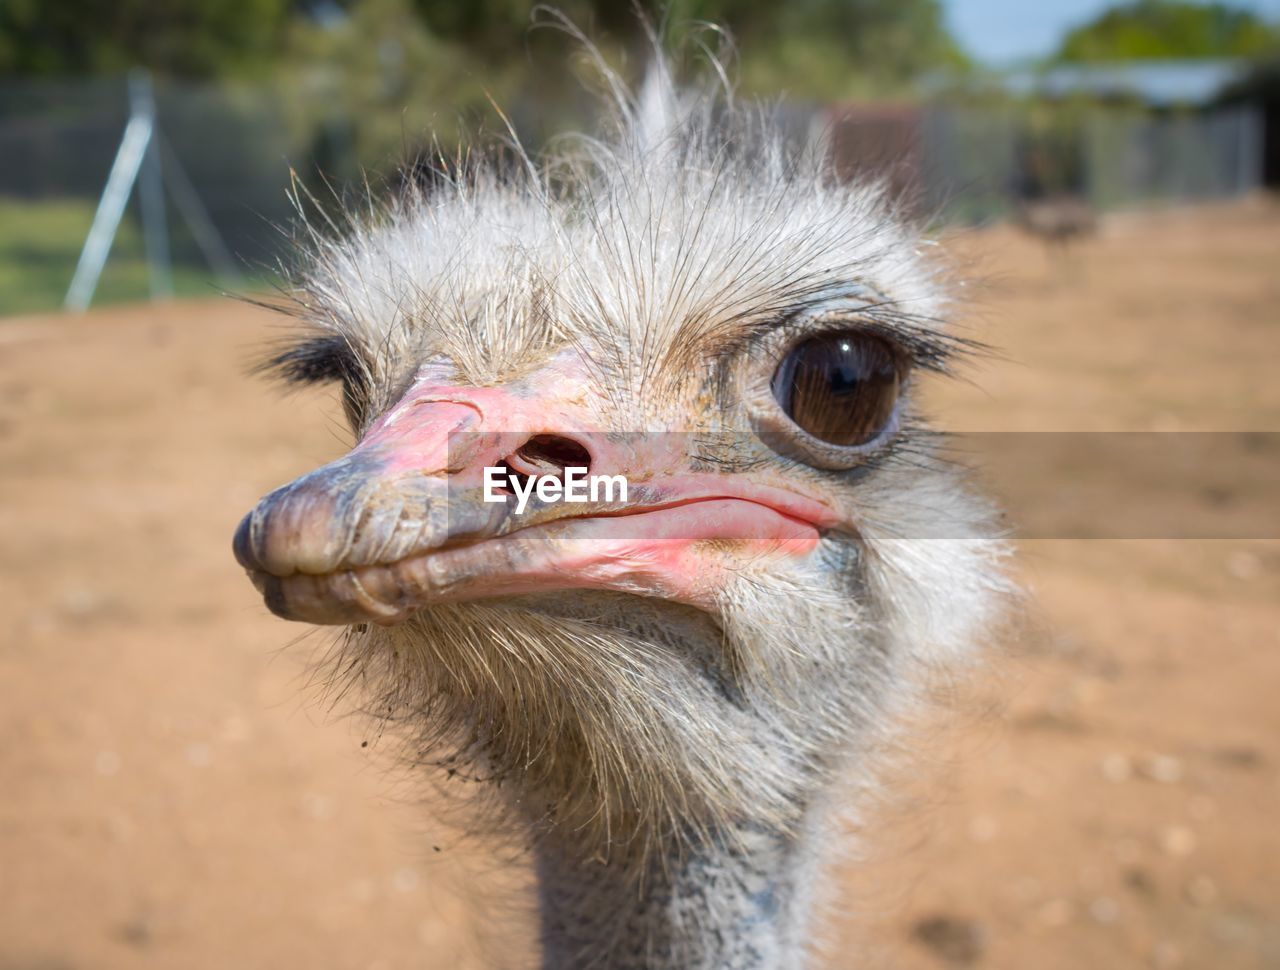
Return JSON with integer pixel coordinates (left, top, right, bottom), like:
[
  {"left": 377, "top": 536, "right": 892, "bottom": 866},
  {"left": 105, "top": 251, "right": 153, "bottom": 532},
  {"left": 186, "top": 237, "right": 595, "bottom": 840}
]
[{"left": 1056, "top": 0, "right": 1280, "bottom": 61}]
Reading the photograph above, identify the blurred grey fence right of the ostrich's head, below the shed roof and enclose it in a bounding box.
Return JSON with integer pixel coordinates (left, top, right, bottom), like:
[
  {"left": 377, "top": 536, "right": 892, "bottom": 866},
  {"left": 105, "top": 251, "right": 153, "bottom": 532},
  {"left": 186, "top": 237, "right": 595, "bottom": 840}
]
[{"left": 824, "top": 105, "right": 1263, "bottom": 224}]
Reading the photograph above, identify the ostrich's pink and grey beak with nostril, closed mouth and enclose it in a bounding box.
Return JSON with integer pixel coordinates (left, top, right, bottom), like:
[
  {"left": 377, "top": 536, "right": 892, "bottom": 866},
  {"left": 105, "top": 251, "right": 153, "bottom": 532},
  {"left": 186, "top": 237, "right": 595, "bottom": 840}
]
[{"left": 236, "top": 357, "right": 836, "bottom": 623}]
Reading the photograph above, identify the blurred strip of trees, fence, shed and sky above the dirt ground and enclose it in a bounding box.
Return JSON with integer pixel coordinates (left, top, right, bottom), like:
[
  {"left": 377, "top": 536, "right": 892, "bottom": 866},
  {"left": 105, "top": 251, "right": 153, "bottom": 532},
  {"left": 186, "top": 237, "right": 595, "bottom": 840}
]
[{"left": 0, "top": 0, "right": 1280, "bottom": 314}]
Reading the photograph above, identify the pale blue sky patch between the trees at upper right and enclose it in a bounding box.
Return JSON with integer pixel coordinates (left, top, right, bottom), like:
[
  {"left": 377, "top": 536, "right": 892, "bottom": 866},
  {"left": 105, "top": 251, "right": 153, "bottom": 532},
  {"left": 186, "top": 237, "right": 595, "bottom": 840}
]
[{"left": 942, "top": 0, "right": 1280, "bottom": 64}]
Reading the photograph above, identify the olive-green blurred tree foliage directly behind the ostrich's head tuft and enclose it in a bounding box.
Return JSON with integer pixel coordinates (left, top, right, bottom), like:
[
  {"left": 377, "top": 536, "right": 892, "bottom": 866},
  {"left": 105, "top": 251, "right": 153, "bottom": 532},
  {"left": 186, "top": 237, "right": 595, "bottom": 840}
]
[{"left": 280, "top": 0, "right": 963, "bottom": 177}]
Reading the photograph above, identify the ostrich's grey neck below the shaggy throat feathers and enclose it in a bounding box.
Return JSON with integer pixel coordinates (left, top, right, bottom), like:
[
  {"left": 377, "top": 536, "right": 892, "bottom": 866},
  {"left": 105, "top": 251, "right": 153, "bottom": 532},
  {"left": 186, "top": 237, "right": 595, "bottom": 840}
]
[{"left": 535, "top": 828, "right": 813, "bottom": 970}]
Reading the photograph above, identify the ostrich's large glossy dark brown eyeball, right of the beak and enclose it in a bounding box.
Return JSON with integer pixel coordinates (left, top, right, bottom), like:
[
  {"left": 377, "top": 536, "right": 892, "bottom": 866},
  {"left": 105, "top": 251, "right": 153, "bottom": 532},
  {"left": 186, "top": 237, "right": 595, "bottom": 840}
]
[{"left": 773, "top": 333, "right": 900, "bottom": 445}]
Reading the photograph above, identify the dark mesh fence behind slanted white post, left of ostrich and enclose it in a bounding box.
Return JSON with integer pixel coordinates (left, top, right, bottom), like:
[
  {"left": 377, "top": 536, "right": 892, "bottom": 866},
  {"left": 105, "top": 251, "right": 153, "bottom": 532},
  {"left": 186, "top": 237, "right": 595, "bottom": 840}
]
[{"left": 0, "top": 78, "right": 307, "bottom": 312}]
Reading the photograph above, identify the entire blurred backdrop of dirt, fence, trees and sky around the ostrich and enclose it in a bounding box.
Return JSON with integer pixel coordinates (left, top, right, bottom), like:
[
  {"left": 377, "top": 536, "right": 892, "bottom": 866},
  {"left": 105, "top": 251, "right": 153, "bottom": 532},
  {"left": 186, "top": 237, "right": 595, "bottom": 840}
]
[{"left": 0, "top": 0, "right": 1280, "bottom": 970}]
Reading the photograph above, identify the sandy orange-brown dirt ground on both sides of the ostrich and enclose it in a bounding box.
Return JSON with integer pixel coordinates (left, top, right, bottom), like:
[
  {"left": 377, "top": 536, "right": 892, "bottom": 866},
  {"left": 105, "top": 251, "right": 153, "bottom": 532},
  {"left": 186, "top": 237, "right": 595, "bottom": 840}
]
[{"left": 0, "top": 201, "right": 1280, "bottom": 970}]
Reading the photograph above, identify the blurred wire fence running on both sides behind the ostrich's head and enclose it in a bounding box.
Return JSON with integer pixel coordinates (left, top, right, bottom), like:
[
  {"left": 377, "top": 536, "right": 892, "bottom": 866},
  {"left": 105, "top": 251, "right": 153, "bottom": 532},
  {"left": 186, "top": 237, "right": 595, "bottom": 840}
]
[{"left": 0, "top": 78, "right": 1262, "bottom": 315}]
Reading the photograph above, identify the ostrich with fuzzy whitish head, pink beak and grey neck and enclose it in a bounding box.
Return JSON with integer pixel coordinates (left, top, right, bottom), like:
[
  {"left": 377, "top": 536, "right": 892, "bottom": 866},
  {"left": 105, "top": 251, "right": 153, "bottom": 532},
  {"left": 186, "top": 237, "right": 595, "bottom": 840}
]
[{"left": 234, "top": 38, "right": 1005, "bottom": 970}]
